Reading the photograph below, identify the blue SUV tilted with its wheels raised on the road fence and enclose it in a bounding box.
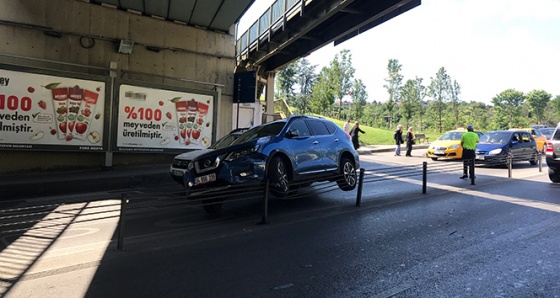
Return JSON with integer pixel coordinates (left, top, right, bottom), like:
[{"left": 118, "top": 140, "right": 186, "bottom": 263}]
[{"left": 184, "top": 116, "right": 360, "bottom": 212}]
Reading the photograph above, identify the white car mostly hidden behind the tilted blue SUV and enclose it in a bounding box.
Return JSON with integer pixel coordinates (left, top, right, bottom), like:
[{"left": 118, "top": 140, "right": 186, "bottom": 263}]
[{"left": 169, "top": 128, "right": 249, "bottom": 186}]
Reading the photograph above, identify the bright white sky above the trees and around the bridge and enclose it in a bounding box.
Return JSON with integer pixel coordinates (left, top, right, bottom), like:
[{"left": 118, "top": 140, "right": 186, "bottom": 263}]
[{"left": 239, "top": 0, "right": 560, "bottom": 104}]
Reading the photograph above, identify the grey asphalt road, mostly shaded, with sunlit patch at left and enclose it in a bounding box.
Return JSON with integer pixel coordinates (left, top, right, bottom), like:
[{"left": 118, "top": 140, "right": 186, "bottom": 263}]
[{"left": 0, "top": 151, "right": 560, "bottom": 297}]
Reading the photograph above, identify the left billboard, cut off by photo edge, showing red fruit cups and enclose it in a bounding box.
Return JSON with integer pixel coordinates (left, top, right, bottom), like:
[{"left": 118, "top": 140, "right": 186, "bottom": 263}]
[{"left": 0, "top": 68, "right": 108, "bottom": 151}]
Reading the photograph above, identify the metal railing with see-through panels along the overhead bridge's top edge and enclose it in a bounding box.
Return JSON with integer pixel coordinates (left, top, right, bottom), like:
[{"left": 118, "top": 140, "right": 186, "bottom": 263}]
[{"left": 235, "top": 0, "right": 312, "bottom": 61}]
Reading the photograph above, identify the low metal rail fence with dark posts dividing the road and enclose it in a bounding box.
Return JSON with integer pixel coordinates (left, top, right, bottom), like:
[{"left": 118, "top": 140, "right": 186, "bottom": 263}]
[{"left": 0, "top": 154, "right": 542, "bottom": 254}]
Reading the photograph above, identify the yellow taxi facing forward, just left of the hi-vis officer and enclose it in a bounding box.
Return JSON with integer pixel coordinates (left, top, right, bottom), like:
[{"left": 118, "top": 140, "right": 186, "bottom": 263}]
[{"left": 428, "top": 128, "right": 482, "bottom": 160}]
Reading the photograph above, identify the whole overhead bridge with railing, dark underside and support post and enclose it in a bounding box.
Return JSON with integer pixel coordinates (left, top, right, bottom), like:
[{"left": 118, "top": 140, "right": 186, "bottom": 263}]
[{"left": 232, "top": 0, "right": 420, "bottom": 120}]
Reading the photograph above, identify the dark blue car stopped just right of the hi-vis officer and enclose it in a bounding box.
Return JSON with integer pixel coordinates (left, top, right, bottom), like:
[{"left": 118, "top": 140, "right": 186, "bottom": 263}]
[{"left": 476, "top": 130, "right": 539, "bottom": 165}]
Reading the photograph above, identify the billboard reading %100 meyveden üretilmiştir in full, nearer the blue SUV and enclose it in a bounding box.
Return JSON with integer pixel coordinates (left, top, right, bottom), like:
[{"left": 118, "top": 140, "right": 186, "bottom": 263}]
[{"left": 114, "top": 83, "right": 216, "bottom": 152}]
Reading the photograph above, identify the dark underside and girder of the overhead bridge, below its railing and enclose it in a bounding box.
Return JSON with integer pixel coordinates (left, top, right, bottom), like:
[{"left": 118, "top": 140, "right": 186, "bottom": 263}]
[{"left": 240, "top": 0, "right": 421, "bottom": 77}]
